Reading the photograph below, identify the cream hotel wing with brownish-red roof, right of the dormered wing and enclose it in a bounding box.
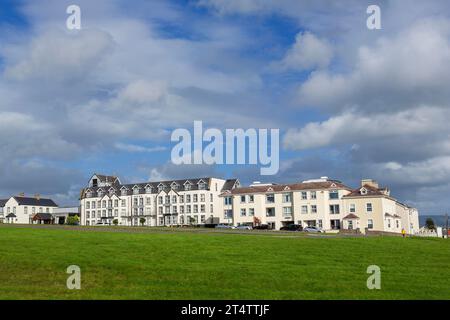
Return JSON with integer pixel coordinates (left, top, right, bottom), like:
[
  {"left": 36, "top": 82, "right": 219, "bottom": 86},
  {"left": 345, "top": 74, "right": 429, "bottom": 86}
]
[{"left": 221, "top": 177, "right": 419, "bottom": 234}]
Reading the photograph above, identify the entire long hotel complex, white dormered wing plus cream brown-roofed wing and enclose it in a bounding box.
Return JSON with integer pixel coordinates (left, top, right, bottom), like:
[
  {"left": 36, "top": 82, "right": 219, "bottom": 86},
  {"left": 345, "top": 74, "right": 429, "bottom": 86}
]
[{"left": 80, "top": 174, "right": 419, "bottom": 234}]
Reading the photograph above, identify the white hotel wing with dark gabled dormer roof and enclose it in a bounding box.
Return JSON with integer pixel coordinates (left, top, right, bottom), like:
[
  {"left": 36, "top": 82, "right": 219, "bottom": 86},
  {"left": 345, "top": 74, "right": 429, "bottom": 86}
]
[{"left": 80, "top": 174, "right": 239, "bottom": 226}]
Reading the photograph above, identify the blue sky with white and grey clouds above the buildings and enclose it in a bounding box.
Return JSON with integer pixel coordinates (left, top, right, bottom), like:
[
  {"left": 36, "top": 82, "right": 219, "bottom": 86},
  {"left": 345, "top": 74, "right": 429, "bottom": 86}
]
[{"left": 0, "top": 0, "right": 450, "bottom": 214}]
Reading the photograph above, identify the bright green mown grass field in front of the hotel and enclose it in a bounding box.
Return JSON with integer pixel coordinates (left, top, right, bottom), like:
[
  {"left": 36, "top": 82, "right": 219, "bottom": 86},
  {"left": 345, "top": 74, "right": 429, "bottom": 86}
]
[{"left": 0, "top": 222, "right": 450, "bottom": 299}]
